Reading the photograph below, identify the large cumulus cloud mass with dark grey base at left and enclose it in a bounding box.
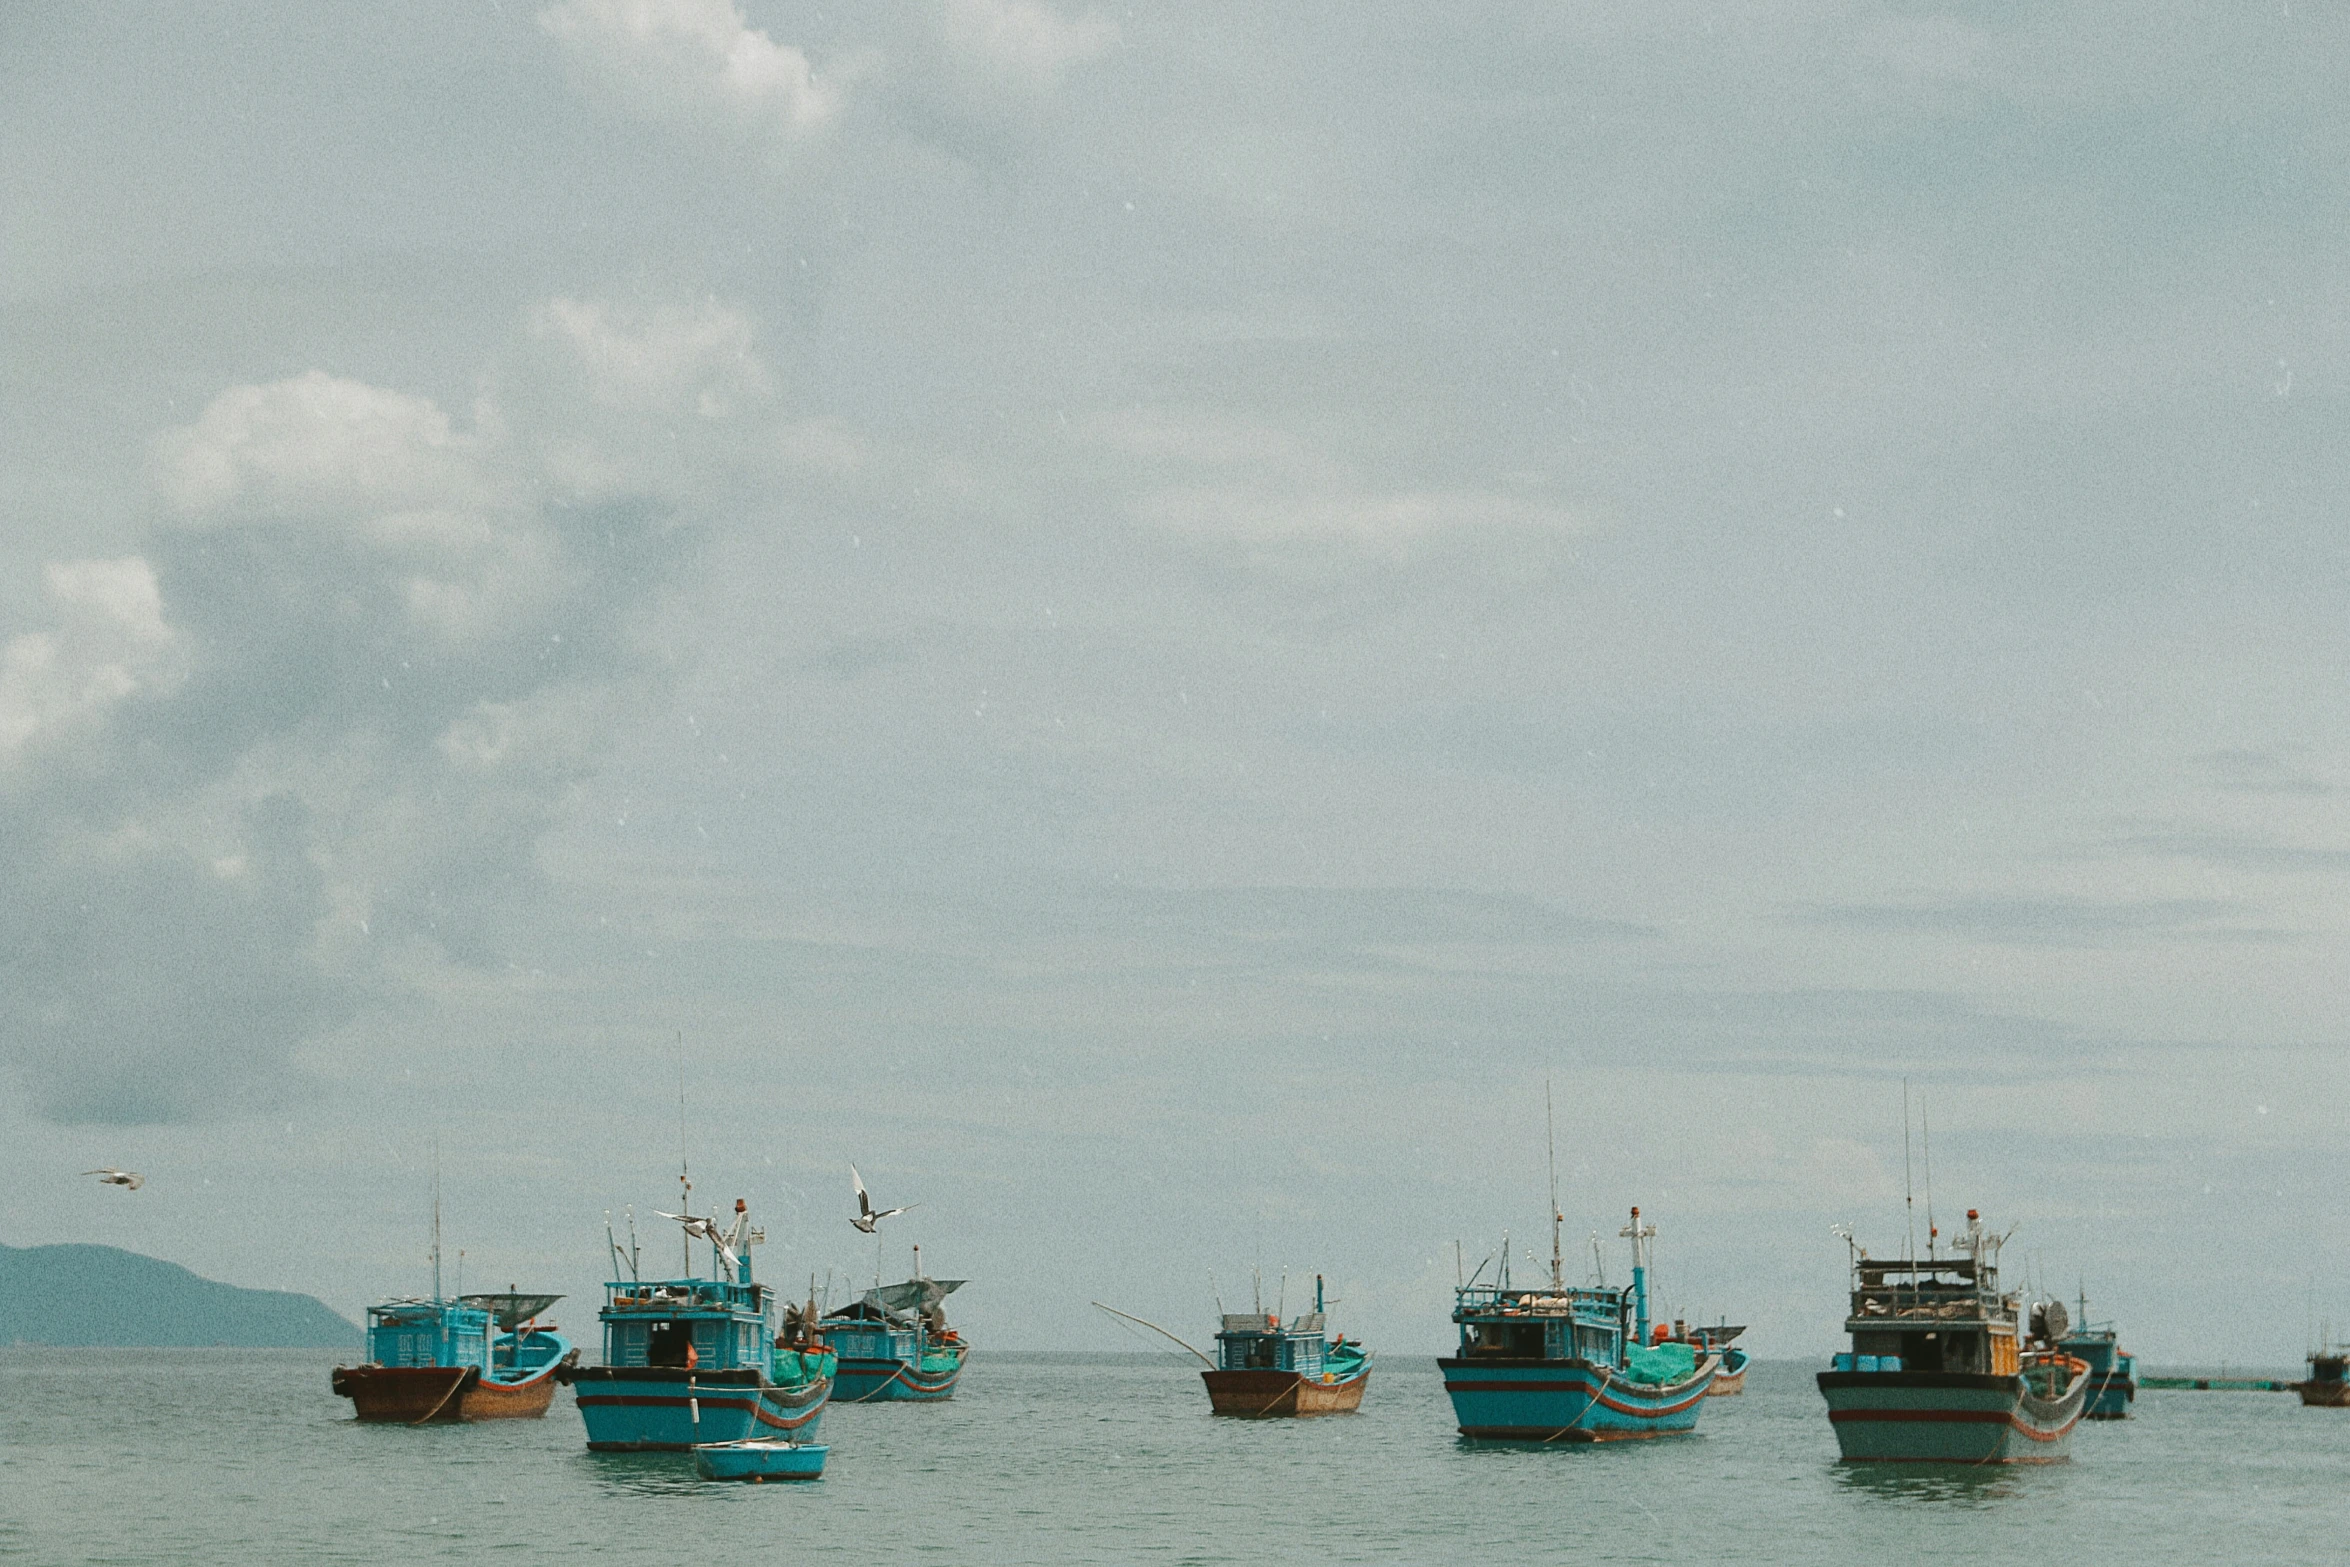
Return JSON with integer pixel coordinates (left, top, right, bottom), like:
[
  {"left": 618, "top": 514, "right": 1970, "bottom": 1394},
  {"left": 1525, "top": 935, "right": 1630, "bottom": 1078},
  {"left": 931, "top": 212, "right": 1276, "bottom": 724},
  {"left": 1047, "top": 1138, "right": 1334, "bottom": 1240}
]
[{"left": 0, "top": 301, "right": 733, "bottom": 1121}]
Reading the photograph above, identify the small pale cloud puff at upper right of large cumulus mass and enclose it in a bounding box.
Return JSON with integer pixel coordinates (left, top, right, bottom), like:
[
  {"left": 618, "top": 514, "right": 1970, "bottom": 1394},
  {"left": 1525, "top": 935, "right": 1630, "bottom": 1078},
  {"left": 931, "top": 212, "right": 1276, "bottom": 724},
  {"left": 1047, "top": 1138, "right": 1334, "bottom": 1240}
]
[{"left": 531, "top": 298, "right": 776, "bottom": 418}]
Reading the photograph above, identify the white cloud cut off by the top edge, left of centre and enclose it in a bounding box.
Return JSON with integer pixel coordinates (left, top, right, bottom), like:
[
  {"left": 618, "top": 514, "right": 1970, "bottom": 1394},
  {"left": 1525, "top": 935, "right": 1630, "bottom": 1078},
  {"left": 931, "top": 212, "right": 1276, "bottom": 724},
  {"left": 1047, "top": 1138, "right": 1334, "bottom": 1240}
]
[{"left": 538, "top": 0, "right": 841, "bottom": 143}]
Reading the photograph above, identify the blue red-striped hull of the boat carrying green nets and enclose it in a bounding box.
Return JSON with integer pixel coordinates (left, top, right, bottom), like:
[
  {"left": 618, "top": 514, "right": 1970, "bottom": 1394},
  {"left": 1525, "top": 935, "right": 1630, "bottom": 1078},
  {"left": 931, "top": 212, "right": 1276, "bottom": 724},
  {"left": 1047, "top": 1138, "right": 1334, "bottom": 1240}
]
[{"left": 1436, "top": 1356, "right": 1723, "bottom": 1442}]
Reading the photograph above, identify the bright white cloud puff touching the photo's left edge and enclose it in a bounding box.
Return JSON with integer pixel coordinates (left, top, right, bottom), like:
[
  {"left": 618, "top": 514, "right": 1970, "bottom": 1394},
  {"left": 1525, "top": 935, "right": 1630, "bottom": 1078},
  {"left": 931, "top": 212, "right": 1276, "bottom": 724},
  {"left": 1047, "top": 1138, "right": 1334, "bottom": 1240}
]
[{"left": 0, "top": 554, "right": 181, "bottom": 764}]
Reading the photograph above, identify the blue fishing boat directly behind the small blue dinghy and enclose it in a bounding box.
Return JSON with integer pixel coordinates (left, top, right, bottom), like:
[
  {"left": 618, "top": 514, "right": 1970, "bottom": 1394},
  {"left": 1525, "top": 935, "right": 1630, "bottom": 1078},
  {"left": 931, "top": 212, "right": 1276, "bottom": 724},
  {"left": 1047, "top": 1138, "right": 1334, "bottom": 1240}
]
[{"left": 564, "top": 1186, "right": 834, "bottom": 1452}]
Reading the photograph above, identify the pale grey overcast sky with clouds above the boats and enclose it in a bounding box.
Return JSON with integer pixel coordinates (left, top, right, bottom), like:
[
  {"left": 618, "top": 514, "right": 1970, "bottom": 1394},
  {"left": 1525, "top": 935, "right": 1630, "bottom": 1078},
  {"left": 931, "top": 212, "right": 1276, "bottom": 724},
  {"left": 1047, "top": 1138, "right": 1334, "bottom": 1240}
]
[{"left": 0, "top": 0, "right": 2350, "bottom": 1363}]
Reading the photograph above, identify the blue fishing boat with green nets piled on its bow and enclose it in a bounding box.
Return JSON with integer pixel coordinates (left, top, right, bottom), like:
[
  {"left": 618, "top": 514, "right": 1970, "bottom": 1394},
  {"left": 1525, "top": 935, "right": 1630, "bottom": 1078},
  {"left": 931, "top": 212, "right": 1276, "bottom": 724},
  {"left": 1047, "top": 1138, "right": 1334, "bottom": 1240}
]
[{"left": 1436, "top": 1198, "right": 1723, "bottom": 1442}]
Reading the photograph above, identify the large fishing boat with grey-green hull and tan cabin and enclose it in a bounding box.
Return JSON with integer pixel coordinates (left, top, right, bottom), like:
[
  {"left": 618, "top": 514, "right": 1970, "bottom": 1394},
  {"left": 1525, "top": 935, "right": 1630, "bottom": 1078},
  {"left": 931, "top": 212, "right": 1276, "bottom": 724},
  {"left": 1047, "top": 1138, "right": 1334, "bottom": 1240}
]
[{"left": 1819, "top": 1208, "right": 2089, "bottom": 1464}]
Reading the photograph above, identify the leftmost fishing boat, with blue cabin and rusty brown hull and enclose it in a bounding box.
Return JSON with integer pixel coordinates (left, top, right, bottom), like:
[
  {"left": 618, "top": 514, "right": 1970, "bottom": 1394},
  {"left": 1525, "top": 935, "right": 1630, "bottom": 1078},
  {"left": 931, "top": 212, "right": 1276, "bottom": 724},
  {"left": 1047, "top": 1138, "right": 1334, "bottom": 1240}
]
[{"left": 331, "top": 1294, "right": 578, "bottom": 1426}]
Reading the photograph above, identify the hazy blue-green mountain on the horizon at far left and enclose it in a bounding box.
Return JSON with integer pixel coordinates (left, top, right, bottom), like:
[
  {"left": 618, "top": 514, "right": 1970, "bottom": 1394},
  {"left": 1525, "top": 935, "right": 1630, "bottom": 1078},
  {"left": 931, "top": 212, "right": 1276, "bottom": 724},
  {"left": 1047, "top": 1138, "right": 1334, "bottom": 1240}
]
[{"left": 0, "top": 1245, "right": 360, "bottom": 1349}]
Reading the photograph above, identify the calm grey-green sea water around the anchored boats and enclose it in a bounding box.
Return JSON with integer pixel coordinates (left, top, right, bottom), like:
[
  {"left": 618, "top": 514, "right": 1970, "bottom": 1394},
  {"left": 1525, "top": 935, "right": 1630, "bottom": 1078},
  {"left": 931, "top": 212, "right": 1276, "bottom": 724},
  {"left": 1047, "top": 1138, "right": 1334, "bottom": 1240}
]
[{"left": 0, "top": 1349, "right": 2350, "bottom": 1567}]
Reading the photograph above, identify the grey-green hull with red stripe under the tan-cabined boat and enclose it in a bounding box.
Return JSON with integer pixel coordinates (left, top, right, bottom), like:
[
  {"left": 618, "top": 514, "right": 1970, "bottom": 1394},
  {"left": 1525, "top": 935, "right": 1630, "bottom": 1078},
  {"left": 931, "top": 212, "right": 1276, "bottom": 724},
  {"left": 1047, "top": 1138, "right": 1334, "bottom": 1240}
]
[{"left": 1819, "top": 1367, "right": 2089, "bottom": 1464}]
